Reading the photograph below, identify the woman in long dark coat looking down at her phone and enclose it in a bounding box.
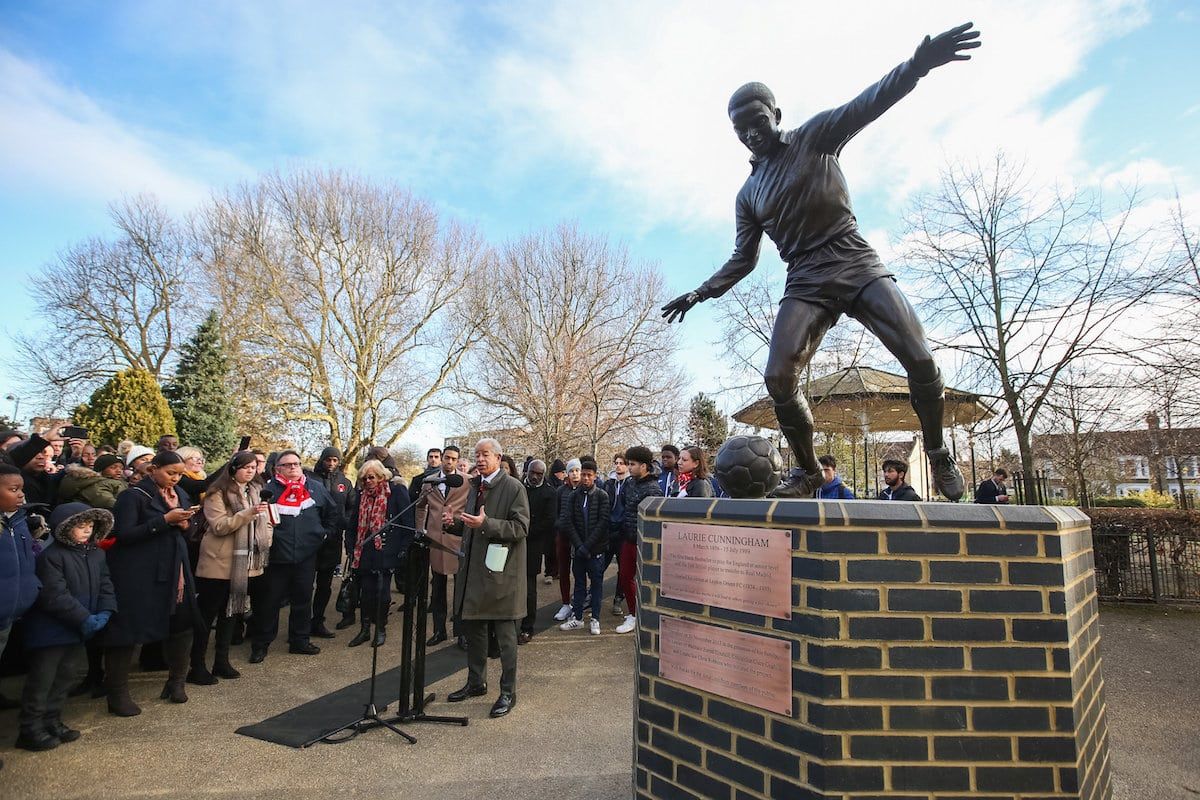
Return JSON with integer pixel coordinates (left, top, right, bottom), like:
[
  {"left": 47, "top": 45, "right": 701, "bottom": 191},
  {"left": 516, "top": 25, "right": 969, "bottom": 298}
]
[{"left": 104, "top": 450, "right": 199, "bottom": 716}]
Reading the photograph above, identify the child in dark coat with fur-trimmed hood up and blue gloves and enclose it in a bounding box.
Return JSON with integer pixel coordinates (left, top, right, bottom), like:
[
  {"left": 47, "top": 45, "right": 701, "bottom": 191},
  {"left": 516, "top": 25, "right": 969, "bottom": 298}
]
[{"left": 17, "top": 503, "right": 116, "bottom": 751}]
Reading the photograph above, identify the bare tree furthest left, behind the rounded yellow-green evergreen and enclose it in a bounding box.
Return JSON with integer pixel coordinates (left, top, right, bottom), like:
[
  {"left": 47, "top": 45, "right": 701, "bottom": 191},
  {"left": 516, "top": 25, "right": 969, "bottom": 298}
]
[{"left": 17, "top": 196, "right": 196, "bottom": 409}]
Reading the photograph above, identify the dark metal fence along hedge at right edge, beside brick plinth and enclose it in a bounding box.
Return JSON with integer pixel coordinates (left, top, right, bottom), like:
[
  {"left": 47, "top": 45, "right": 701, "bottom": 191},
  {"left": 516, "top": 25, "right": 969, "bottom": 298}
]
[{"left": 1092, "top": 525, "right": 1200, "bottom": 602}]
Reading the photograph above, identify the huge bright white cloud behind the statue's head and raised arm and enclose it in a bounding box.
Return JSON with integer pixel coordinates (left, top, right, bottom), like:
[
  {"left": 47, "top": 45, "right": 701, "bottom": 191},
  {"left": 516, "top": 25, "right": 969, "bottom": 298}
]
[{"left": 488, "top": 0, "right": 1146, "bottom": 231}]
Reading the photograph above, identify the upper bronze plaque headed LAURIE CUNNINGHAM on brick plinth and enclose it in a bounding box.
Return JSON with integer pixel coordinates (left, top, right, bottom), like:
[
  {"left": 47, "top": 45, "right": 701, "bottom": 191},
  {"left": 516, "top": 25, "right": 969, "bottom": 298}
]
[{"left": 659, "top": 522, "right": 792, "bottom": 619}]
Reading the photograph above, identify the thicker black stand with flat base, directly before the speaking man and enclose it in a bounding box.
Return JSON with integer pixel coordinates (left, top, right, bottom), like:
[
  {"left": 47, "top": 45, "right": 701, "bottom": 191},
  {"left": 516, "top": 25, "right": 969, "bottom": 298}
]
[{"left": 392, "top": 531, "right": 470, "bottom": 726}]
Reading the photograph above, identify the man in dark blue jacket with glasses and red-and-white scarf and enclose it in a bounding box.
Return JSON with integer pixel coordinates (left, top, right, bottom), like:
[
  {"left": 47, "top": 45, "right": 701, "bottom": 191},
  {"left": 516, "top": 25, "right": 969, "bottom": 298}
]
[{"left": 250, "top": 450, "right": 340, "bottom": 663}]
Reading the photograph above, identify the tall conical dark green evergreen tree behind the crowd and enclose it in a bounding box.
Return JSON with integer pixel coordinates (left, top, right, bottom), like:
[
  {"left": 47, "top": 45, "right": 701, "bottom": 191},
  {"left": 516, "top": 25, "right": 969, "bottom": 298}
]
[{"left": 163, "top": 312, "right": 238, "bottom": 462}]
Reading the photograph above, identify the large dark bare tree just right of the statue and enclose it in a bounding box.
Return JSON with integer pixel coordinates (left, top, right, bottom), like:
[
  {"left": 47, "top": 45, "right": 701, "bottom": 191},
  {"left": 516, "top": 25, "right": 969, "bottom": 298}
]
[{"left": 904, "top": 154, "right": 1175, "bottom": 497}]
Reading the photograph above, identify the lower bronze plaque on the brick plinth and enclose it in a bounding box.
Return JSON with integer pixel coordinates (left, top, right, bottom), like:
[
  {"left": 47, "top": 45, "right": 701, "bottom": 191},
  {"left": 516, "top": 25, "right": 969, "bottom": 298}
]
[{"left": 659, "top": 616, "right": 792, "bottom": 716}]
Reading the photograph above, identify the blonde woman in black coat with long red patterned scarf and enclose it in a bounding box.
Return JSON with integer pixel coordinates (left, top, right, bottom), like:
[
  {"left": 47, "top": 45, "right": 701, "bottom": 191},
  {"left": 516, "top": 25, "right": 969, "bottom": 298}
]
[{"left": 346, "top": 459, "right": 416, "bottom": 648}]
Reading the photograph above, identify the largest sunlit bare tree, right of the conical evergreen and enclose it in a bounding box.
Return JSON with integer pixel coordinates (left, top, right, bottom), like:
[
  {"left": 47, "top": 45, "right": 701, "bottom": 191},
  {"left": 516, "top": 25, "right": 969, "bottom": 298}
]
[{"left": 203, "top": 172, "right": 492, "bottom": 453}]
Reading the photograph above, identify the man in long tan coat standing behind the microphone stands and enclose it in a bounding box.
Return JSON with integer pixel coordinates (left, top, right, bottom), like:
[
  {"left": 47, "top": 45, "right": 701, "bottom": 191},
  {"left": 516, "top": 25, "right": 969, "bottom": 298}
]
[{"left": 416, "top": 445, "right": 468, "bottom": 648}]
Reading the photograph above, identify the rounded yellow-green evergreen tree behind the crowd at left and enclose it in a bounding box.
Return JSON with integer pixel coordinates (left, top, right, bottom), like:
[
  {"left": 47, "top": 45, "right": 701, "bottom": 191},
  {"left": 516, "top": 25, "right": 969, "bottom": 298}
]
[{"left": 73, "top": 367, "right": 175, "bottom": 446}]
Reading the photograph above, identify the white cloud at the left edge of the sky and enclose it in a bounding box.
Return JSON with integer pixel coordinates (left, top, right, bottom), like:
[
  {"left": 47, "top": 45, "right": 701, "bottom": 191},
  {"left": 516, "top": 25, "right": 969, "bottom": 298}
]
[{"left": 0, "top": 48, "right": 246, "bottom": 209}]
